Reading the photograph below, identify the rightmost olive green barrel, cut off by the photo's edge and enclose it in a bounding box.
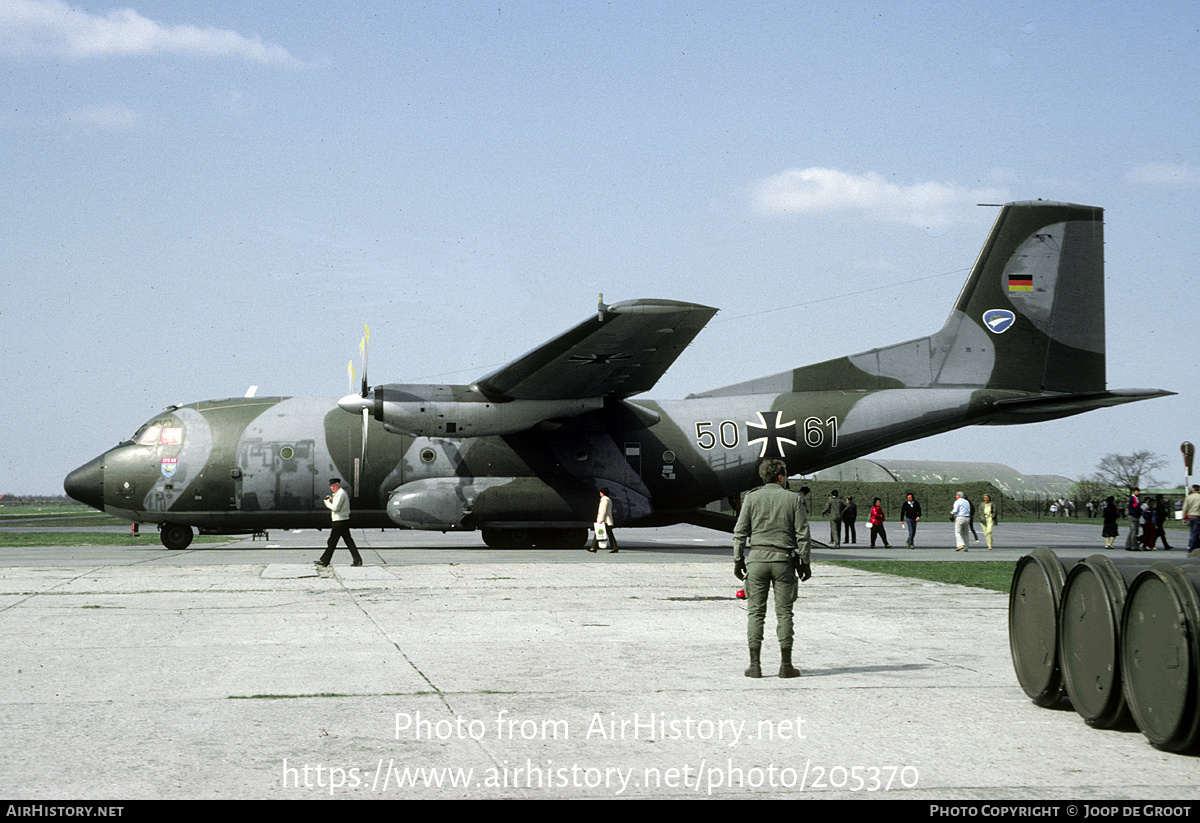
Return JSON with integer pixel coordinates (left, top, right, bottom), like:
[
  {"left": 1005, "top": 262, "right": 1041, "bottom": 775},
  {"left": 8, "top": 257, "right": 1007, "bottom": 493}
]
[{"left": 1121, "top": 563, "right": 1200, "bottom": 751}]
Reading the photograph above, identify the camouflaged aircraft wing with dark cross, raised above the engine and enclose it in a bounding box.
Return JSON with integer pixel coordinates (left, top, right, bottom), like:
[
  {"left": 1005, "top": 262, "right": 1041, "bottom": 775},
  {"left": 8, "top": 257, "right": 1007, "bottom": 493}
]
[{"left": 475, "top": 300, "right": 716, "bottom": 401}]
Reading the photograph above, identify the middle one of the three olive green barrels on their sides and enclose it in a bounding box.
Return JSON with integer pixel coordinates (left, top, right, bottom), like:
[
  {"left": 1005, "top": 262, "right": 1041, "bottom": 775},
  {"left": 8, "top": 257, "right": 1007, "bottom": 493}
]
[{"left": 1058, "top": 554, "right": 1200, "bottom": 728}]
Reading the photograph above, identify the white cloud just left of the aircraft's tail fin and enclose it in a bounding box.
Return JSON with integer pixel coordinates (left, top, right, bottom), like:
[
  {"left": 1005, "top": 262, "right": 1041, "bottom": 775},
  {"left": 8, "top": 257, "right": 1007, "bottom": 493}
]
[{"left": 752, "top": 168, "right": 1008, "bottom": 229}]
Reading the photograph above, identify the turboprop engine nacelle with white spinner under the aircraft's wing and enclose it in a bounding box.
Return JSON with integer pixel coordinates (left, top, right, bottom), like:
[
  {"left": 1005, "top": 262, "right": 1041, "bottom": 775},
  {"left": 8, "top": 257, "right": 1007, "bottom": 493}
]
[{"left": 338, "top": 384, "right": 604, "bottom": 438}]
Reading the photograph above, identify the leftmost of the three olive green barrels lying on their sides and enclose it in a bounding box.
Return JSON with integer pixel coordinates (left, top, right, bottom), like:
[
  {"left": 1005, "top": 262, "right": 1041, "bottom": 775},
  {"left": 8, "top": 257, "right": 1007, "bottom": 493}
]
[{"left": 1008, "top": 548, "right": 1079, "bottom": 707}]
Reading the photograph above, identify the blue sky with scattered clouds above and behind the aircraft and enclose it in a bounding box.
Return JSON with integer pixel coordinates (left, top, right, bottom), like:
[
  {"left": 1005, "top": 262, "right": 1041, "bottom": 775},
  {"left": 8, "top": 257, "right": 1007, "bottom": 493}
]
[{"left": 0, "top": 0, "right": 1200, "bottom": 493}]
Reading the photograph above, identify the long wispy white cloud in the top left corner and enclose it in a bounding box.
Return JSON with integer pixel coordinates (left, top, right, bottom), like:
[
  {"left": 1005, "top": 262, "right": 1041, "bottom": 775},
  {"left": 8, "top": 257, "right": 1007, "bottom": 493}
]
[{"left": 0, "top": 0, "right": 300, "bottom": 65}]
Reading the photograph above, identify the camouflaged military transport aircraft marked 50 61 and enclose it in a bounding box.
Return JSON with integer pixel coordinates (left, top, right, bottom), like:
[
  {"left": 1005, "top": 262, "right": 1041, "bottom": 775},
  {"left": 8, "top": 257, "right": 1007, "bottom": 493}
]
[{"left": 64, "top": 200, "right": 1171, "bottom": 548}]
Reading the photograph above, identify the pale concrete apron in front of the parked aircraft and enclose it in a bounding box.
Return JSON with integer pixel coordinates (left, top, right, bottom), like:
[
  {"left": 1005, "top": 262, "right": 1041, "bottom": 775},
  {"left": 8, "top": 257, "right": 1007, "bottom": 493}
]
[{"left": 0, "top": 561, "right": 1200, "bottom": 800}]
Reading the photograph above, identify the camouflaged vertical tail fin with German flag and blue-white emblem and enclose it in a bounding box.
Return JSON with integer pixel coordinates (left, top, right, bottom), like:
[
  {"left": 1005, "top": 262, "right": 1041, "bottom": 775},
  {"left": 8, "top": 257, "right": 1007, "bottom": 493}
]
[{"left": 694, "top": 200, "right": 1105, "bottom": 397}]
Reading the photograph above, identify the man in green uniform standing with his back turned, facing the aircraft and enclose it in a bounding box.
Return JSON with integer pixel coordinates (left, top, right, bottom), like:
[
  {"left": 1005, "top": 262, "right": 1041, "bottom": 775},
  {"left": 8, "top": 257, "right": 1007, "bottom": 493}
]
[{"left": 733, "top": 459, "right": 812, "bottom": 678}]
